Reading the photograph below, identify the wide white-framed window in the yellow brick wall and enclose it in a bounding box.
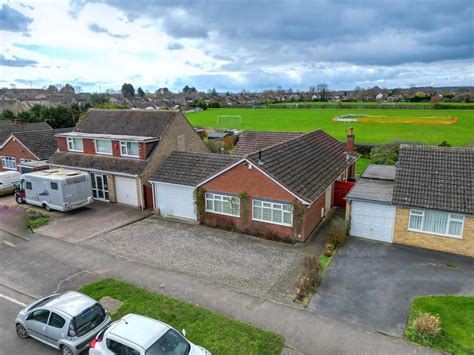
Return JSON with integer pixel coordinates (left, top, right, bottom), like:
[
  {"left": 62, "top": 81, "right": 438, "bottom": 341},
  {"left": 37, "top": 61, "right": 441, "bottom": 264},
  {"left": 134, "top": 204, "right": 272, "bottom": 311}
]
[{"left": 408, "top": 209, "right": 464, "bottom": 239}]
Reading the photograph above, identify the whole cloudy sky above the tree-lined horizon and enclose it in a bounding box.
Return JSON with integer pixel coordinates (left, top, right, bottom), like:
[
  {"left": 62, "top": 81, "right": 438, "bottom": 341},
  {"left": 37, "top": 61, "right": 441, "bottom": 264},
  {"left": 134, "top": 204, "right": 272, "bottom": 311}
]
[{"left": 0, "top": 0, "right": 474, "bottom": 92}]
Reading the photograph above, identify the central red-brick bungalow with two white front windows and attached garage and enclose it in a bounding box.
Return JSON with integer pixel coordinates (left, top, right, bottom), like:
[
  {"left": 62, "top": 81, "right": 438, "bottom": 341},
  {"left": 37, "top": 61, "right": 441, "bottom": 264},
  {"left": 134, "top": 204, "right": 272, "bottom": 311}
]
[{"left": 152, "top": 130, "right": 357, "bottom": 241}]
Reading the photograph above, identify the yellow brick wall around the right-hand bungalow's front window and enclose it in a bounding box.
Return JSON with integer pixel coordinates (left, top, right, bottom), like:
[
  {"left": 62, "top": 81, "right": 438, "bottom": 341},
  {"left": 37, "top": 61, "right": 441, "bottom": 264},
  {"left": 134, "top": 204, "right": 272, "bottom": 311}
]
[{"left": 393, "top": 207, "right": 474, "bottom": 257}]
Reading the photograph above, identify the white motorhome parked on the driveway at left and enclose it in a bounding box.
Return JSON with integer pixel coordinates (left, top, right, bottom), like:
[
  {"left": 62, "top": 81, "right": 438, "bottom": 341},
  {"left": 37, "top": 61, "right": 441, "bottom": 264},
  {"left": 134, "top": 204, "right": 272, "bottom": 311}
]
[{"left": 16, "top": 169, "right": 93, "bottom": 212}]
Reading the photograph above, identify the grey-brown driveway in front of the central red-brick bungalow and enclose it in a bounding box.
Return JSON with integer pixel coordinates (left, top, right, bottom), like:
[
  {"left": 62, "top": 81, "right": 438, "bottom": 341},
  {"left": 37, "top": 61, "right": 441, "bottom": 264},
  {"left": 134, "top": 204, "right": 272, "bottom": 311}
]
[{"left": 83, "top": 217, "right": 303, "bottom": 296}]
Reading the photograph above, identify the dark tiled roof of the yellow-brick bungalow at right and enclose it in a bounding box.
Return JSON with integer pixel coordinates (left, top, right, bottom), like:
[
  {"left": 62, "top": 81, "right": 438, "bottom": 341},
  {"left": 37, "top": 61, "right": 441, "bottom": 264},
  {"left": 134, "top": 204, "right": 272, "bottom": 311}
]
[{"left": 393, "top": 145, "right": 474, "bottom": 214}]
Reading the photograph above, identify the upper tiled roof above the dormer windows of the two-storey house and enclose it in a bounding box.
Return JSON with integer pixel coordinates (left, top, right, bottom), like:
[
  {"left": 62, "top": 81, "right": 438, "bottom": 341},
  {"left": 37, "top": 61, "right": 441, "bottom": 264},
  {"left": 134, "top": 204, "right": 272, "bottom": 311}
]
[{"left": 74, "top": 109, "right": 182, "bottom": 138}]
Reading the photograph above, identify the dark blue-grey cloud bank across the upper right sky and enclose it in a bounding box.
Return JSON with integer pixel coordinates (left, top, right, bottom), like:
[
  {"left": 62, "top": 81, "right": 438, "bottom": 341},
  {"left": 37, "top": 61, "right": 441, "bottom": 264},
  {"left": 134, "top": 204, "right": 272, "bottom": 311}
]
[{"left": 73, "top": 0, "right": 474, "bottom": 65}]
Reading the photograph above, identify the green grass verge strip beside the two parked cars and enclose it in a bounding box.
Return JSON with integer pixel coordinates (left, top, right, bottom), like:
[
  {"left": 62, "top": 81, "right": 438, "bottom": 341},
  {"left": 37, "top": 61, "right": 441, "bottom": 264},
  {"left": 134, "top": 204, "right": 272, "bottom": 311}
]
[{"left": 80, "top": 279, "right": 284, "bottom": 354}]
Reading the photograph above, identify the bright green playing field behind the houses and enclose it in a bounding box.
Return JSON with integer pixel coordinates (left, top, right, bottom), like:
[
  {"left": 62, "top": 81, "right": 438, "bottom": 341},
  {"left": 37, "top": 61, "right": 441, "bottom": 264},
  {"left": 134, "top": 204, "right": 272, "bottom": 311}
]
[{"left": 186, "top": 108, "right": 474, "bottom": 146}]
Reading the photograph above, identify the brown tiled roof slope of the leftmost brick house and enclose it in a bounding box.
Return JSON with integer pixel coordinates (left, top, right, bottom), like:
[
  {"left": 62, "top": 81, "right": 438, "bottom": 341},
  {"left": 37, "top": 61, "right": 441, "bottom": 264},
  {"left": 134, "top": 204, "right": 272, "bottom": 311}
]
[{"left": 13, "top": 128, "right": 72, "bottom": 160}]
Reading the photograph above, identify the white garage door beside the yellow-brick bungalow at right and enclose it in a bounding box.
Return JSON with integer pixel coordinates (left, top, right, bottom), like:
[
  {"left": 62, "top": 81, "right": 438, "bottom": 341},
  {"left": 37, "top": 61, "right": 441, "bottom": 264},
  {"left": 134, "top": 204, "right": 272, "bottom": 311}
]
[{"left": 351, "top": 201, "right": 395, "bottom": 243}]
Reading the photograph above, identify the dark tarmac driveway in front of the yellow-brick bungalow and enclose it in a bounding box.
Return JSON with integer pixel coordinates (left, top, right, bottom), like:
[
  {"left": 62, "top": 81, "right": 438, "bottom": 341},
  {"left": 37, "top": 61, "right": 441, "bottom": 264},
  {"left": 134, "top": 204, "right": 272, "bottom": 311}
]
[{"left": 309, "top": 238, "right": 474, "bottom": 336}]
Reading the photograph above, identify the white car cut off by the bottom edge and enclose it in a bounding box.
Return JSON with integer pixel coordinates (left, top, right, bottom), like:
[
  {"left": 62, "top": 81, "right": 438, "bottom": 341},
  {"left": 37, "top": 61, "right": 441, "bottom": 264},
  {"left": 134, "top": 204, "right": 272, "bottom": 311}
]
[{"left": 89, "top": 314, "right": 211, "bottom": 355}]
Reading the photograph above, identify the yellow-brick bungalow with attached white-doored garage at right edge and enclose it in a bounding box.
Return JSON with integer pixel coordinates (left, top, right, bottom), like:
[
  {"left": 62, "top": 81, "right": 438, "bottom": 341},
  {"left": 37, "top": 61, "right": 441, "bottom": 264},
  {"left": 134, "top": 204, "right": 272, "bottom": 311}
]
[{"left": 347, "top": 145, "right": 474, "bottom": 257}]
